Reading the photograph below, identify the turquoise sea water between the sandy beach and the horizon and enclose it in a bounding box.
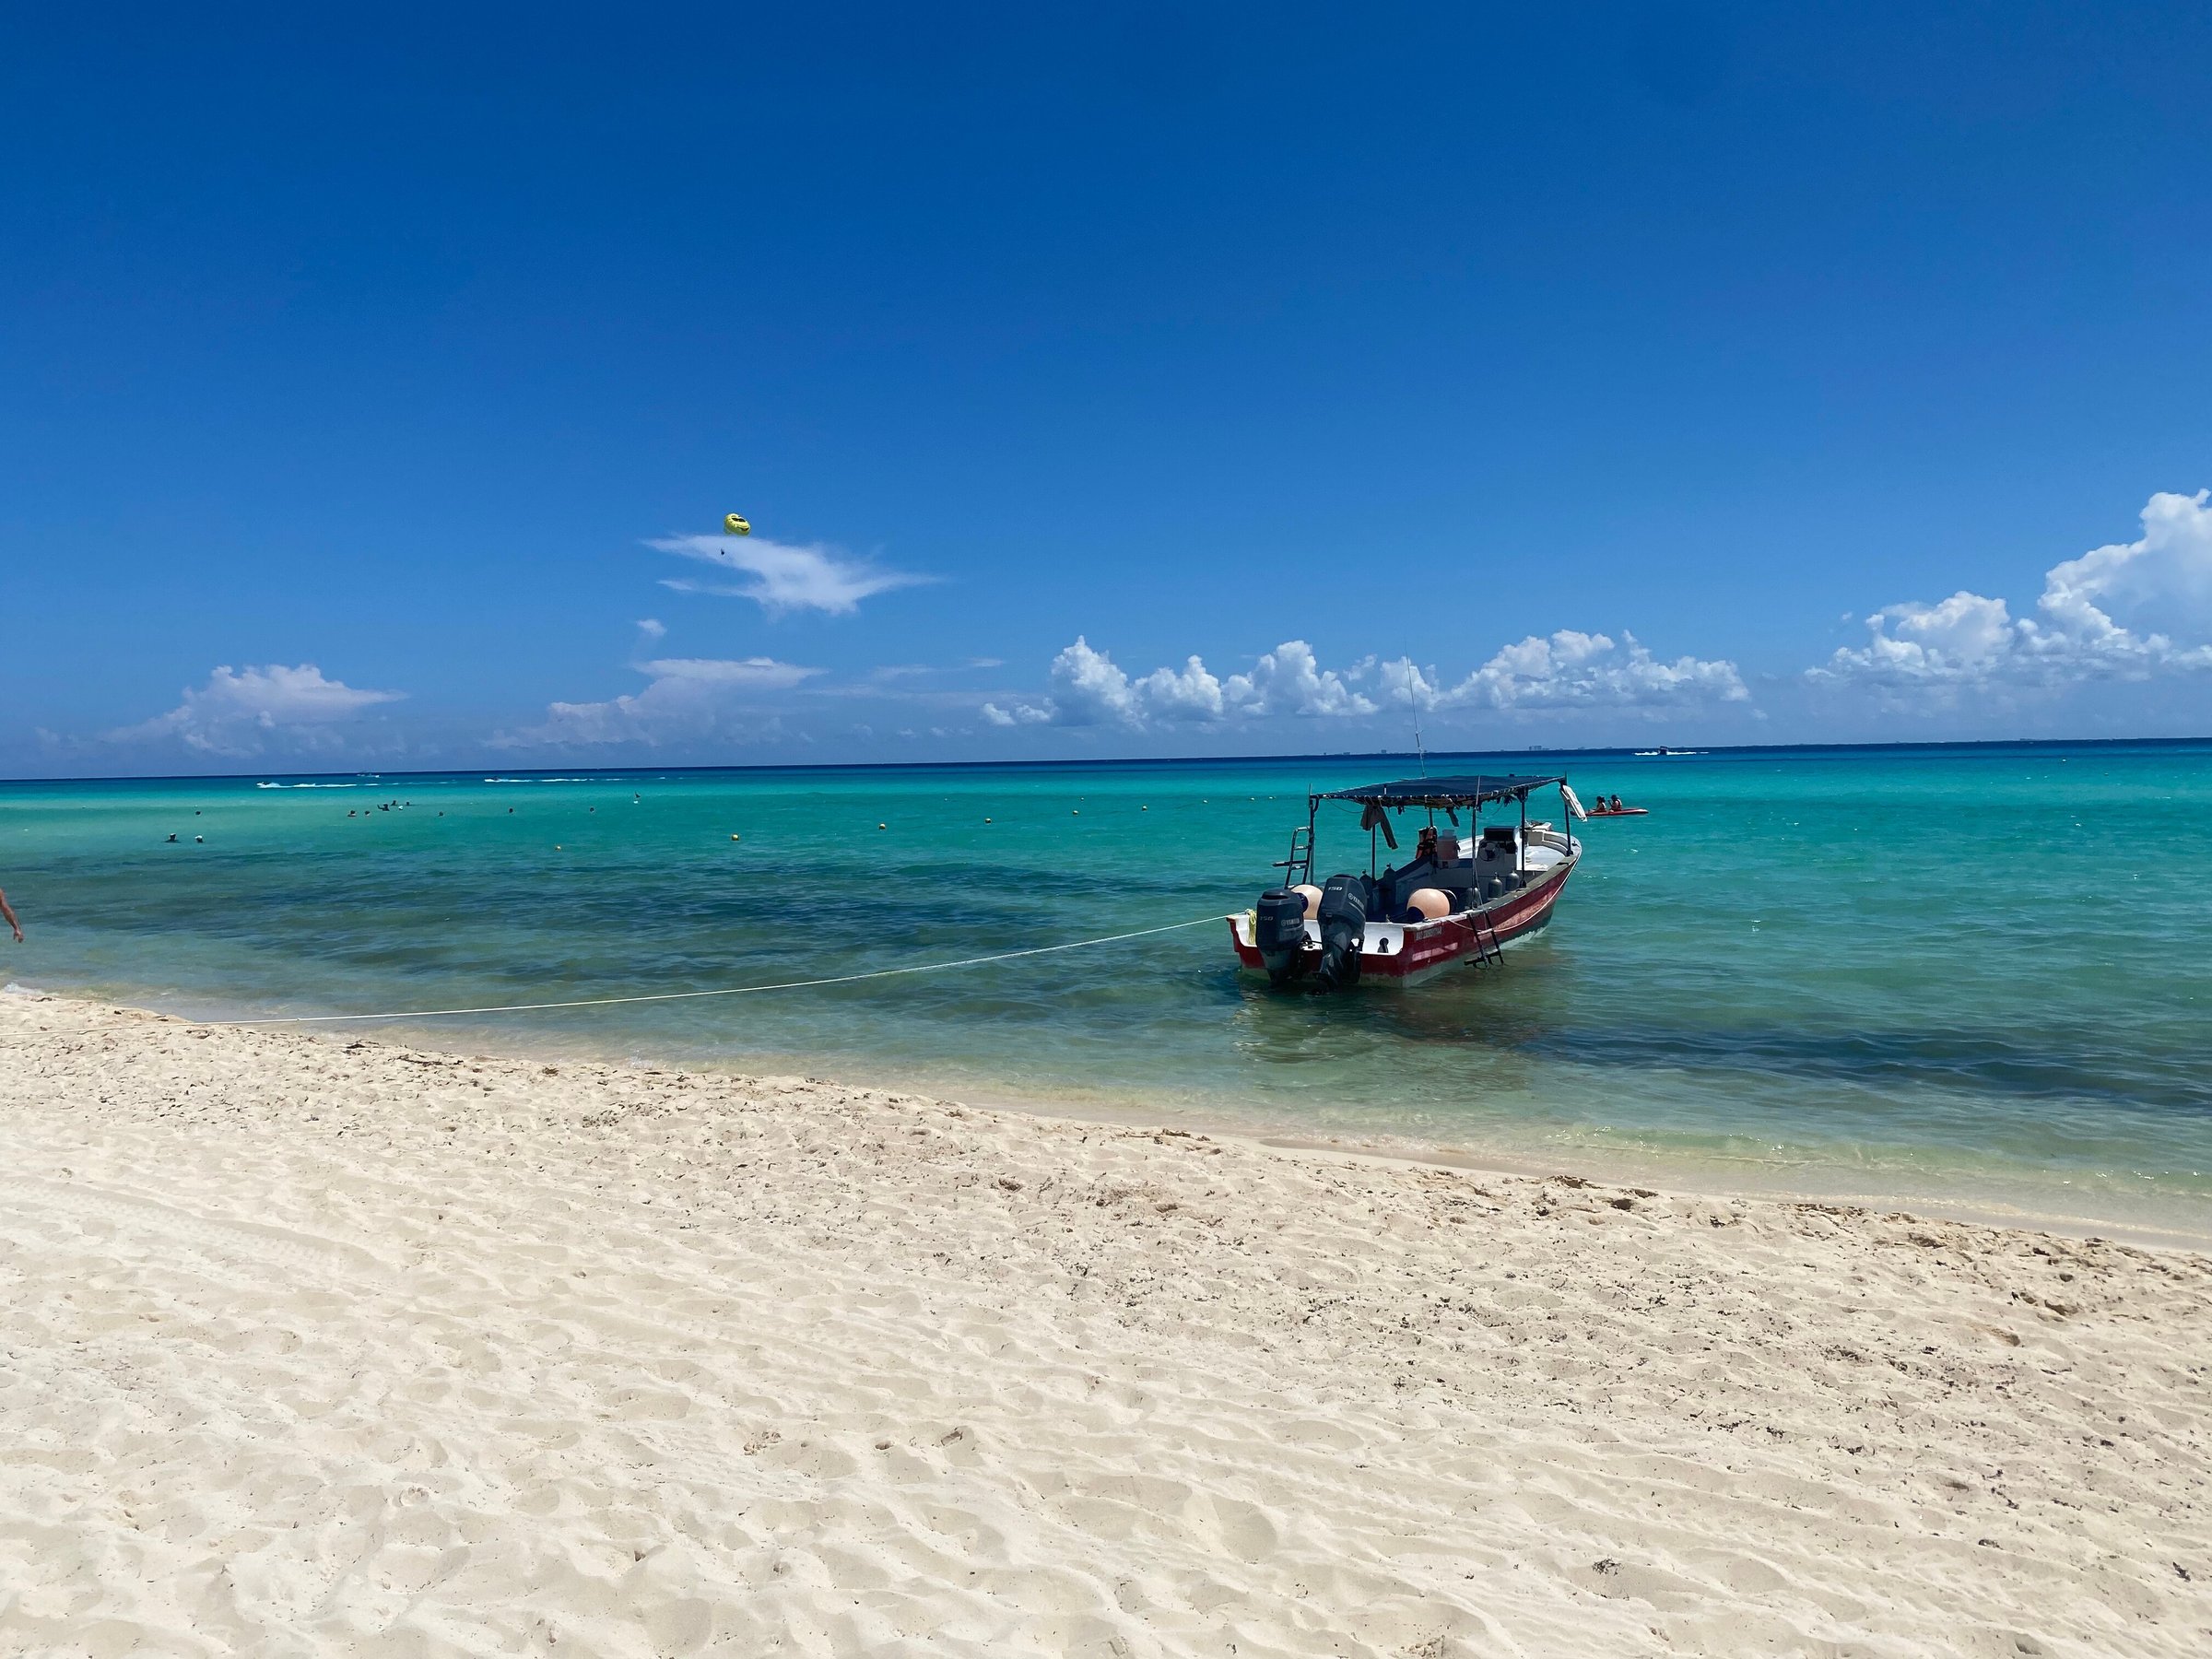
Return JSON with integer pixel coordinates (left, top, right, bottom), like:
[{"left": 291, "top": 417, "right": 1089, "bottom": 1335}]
[{"left": 0, "top": 746, "right": 2212, "bottom": 1234}]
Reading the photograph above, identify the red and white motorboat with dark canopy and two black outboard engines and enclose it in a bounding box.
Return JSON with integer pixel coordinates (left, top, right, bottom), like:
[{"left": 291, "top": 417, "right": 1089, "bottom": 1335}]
[{"left": 1228, "top": 776, "right": 1586, "bottom": 991}]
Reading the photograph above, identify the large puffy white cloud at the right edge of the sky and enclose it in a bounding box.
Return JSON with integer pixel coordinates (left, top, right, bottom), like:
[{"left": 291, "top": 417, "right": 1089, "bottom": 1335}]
[{"left": 1807, "top": 491, "right": 2212, "bottom": 692}]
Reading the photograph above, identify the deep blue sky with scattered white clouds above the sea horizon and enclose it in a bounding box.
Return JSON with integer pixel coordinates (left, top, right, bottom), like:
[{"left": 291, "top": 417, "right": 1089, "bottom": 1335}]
[{"left": 0, "top": 2, "right": 2212, "bottom": 776}]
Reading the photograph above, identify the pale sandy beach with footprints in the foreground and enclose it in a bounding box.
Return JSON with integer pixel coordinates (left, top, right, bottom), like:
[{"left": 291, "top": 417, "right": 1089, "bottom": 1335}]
[{"left": 0, "top": 997, "right": 2212, "bottom": 1659}]
